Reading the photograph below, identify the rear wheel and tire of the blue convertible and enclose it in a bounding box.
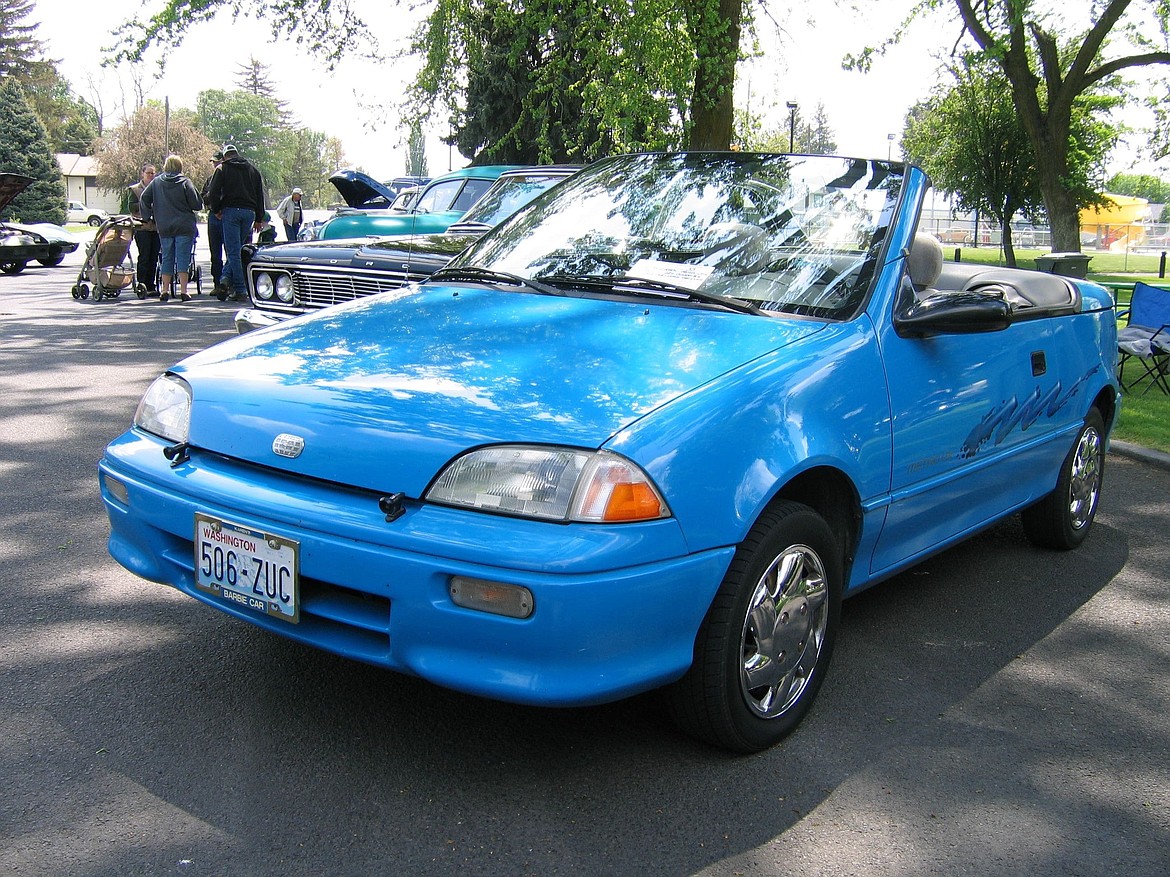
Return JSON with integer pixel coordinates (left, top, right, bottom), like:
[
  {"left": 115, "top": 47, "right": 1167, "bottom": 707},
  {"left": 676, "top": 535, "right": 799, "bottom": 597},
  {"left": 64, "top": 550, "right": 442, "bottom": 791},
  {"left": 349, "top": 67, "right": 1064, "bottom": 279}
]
[{"left": 1020, "top": 408, "right": 1104, "bottom": 551}]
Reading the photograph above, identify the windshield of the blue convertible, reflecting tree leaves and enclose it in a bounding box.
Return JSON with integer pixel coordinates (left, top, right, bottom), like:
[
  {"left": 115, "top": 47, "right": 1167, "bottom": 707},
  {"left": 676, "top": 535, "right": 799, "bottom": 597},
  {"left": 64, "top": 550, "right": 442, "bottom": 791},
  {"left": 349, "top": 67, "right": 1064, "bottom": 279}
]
[{"left": 452, "top": 152, "right": 902, "bottom": 319}]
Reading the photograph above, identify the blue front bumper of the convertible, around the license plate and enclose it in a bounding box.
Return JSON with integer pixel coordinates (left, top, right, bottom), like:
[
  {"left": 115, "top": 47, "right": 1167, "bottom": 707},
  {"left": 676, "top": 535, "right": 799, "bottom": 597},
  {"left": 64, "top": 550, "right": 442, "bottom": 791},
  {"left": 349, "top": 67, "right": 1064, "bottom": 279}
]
[{"left": 99, "top": 431, "right": 734, "bottom": 706}]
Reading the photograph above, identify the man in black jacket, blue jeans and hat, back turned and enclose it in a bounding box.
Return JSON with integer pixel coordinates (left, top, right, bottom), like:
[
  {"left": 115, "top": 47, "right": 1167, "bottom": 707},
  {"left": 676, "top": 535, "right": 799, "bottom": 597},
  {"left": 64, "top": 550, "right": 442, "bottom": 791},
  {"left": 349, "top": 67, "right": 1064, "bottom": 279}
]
[{"left": 207, "top": 143, "right": 264, "bottom": 302}]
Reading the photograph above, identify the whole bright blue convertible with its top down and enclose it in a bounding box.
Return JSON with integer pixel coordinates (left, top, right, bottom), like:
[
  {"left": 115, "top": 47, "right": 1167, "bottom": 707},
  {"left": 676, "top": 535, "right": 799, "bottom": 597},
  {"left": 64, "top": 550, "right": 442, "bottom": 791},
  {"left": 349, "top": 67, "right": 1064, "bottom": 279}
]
[{"left": 101, "top": 153, "right": 1119, "bottom": 752}]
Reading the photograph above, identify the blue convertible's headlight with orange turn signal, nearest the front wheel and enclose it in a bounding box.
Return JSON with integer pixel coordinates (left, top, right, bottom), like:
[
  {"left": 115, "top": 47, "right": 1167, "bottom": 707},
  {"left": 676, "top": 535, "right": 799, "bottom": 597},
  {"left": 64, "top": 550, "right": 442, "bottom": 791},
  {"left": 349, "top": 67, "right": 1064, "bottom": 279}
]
[{"left": 426, "top": 444, "right": 670, "bottom": 523}]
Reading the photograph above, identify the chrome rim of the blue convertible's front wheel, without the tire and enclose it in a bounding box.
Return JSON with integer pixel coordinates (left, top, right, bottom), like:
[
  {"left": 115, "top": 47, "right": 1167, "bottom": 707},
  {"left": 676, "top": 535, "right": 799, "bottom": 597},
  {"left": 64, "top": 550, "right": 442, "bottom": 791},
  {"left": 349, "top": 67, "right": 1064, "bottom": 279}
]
[{"left": 739, "top": 547, "right": 833, "bottom": 719}]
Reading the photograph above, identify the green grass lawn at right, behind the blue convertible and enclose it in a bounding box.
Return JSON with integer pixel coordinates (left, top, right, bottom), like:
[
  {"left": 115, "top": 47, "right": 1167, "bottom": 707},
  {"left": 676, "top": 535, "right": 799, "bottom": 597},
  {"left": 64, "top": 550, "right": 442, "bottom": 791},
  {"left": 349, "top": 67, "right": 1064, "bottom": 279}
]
[{"left": 943, "top": 247, "right": 1170, "bottom": 454}]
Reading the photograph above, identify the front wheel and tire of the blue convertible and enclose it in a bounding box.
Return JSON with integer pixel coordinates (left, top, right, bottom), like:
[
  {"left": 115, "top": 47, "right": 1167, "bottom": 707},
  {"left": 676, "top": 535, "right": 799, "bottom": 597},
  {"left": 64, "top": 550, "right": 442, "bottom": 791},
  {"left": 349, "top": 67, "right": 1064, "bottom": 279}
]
[{"left": 666, "top": 502, "right": 844, "bottom": 753}]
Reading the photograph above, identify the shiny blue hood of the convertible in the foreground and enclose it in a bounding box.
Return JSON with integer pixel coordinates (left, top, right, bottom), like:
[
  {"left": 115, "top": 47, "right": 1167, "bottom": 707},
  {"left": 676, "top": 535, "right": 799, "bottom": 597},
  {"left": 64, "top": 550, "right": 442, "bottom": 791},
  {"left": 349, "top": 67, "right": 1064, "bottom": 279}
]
[{"left": 173, "top": 283, "right": 823, "bottom": 497}]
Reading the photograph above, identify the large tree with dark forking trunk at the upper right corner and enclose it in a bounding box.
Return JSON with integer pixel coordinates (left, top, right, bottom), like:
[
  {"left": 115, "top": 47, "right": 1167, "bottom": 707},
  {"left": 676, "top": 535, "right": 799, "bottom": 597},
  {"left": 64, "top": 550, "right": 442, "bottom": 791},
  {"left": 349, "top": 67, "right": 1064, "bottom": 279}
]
[{"left": 851, "top": 0, "right": 1170, "bottom": 253}]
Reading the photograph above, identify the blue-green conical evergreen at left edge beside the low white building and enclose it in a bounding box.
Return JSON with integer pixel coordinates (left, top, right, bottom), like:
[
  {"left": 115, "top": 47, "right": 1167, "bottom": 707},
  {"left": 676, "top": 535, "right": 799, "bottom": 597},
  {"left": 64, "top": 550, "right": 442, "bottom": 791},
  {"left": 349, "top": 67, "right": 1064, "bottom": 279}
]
[{"left": 0, "top": 76, "right": 66, "bottom": 225}]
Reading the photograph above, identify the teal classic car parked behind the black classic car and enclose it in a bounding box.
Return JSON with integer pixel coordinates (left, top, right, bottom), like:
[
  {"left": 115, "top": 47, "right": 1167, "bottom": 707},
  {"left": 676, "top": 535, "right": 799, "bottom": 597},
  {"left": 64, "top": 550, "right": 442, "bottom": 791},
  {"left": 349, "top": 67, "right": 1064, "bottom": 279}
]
[{"left": 315, "top": 165, "right": 518, "bottom": 241}]
